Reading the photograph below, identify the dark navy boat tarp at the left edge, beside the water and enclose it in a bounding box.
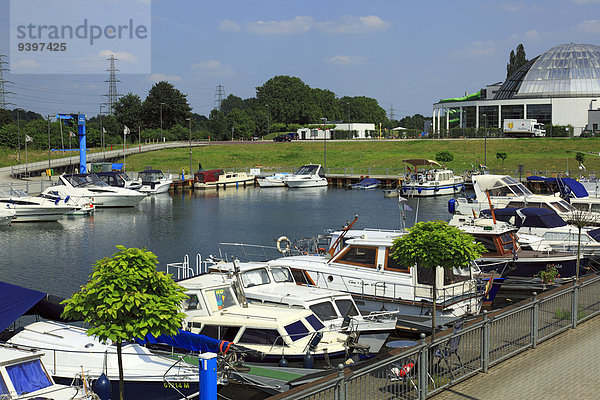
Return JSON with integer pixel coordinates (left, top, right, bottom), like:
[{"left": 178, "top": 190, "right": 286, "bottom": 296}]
[{"left": 0, "top": 282, "right": 46, "bottom": 332}]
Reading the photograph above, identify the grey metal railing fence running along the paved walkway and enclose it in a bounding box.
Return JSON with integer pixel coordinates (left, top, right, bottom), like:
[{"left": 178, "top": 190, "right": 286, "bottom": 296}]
[{"left": 271, "top": 275, "right": 600, "bottom": 400}]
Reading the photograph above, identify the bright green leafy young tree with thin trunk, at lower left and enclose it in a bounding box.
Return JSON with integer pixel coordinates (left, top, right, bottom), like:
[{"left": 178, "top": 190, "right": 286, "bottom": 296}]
[{"left": 62, "top": 246, "right": 186, "bottom": 400}]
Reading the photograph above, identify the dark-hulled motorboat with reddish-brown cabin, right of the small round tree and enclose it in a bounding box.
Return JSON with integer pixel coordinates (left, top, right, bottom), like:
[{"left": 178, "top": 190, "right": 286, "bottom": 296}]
[{"left": 449, "top": 215, "right": 588, "bottom": 280}]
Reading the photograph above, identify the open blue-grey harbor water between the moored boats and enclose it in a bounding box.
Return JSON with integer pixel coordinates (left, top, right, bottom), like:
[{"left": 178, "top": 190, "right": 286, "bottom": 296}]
[{"left": 0, "top": 187, "right": 450, "bottom": 297}]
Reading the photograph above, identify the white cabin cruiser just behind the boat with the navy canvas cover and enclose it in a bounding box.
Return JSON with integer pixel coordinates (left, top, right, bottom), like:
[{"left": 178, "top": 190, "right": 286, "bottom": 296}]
[{"left": 448, "top": 175, "right": 600, "bottom": 222}]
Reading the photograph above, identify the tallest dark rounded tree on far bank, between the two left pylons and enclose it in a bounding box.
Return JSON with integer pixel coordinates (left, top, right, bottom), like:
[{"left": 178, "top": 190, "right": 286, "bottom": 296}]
[{"left": 142, "top": 81, "right": 191, "bottom": 129}]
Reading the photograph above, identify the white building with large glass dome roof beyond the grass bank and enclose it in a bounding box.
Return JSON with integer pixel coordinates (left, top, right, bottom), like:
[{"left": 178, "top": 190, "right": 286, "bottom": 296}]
[{"left": 433, "top": 43, "right": 600, "bottom": 135}]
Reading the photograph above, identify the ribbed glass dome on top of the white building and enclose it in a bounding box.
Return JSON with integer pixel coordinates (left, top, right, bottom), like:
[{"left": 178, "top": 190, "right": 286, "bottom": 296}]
[{"left": 515, "top": 43, "right": 600, "bottom": 97}]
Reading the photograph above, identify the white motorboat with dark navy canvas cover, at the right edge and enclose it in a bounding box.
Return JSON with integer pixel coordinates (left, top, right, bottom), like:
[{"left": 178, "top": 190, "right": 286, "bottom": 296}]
[{"left": 482, "top": 208, "right": 600, "bottom": 257}]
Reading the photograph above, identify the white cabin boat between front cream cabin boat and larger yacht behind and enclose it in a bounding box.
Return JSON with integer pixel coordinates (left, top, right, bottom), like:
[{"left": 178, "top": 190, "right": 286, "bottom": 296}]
[{"left": 206, "top": 262, "right": 396, "bottom": 334}]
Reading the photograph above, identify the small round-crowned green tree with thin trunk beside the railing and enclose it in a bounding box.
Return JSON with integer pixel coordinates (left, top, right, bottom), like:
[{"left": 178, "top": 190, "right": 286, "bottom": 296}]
[{"left": 392, "top": 221, "right": 485, "bottom": 338}]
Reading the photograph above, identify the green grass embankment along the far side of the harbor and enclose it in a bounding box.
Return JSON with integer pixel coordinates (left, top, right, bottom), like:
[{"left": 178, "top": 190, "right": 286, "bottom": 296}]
[{"left": 0, "top": 138, "right": 600, "bottom": 174}]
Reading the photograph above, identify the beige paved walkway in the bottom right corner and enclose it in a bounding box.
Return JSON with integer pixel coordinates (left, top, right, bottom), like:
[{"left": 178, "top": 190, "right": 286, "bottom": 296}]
[{"left": 432, "top": 317, "right": 600, "bottom": 400}]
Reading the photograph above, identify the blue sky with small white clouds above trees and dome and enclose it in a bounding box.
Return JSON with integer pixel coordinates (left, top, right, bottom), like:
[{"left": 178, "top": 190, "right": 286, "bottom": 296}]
[{"left": 0, "top": 0, "right": 600, "bottom": 118}]
